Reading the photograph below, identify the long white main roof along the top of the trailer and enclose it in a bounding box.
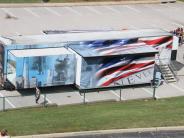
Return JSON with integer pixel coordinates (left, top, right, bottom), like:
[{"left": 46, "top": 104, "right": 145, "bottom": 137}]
[{"left": 0, "top": 29, "right": 172, "bottom": 45}]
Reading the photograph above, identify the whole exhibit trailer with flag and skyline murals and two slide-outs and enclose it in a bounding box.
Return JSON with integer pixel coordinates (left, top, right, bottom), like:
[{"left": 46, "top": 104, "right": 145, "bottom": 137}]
[{"left": 0, "top": 29, "right": 177, "bottom": 89}]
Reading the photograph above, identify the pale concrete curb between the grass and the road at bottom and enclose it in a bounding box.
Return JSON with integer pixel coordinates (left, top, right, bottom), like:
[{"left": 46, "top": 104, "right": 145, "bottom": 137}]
[{"left": 13, "top": 126, "right": 184, "bottom": 138}]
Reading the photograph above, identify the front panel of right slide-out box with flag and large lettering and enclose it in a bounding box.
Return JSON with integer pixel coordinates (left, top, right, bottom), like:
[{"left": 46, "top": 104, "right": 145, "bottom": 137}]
[{"left": 80, "top": 54, "right": 154, "bottom": 88}]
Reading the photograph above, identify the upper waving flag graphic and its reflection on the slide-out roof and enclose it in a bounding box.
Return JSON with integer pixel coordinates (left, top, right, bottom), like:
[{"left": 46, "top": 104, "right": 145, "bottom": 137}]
[{"left": 85, "top": 36, "right": 173, "bottom": 56}]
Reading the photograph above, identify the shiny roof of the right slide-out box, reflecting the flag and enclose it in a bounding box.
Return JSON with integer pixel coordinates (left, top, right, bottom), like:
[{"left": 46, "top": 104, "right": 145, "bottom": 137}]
[{"left": 69, "top": 43, "right": 158, "bottom": 58}]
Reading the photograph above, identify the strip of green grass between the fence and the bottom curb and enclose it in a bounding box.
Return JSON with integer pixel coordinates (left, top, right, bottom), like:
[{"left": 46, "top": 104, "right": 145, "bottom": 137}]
[{"left": 0, "top": 97, "right": 184, "bottom": 135}]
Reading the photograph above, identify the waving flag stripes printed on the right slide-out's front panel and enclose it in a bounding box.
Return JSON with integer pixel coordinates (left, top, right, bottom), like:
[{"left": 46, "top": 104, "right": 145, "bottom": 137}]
[{"left": 95, "top": 55, "right": 155, "bottom": 87}]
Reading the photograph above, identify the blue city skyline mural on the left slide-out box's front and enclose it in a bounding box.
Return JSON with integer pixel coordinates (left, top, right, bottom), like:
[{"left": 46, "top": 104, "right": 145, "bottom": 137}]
[{"left": 7, "top": 52, "right": 75, "bottom": 89}]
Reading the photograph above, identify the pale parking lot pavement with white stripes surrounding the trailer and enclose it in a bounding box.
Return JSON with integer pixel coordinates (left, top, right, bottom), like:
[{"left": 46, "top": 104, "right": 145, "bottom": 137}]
[{"left": 0, "top": 2, "right": 184, "bottom": 110}]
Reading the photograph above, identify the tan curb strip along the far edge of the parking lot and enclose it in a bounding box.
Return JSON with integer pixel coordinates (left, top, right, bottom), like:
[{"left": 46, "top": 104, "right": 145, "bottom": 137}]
[{"left": 0, "top": 0, "right": 161, "bottom": 8}]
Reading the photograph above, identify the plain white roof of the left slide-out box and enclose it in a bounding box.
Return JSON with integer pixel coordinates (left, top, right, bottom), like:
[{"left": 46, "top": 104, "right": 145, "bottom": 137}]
[{"left": 10, "top": 47, "right": 72, "bottom": 57}]
